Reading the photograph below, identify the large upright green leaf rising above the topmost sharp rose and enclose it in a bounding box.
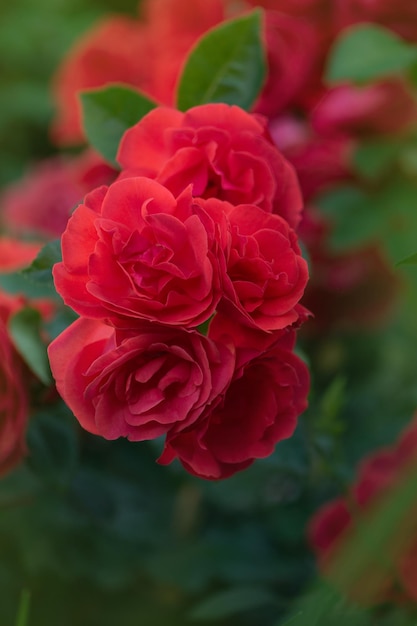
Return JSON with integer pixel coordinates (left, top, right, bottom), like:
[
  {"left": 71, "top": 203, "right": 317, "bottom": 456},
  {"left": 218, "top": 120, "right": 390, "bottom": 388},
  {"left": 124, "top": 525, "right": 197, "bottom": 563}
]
[{"left": 177, "top": 9, "right": 266, "bottom": 111}]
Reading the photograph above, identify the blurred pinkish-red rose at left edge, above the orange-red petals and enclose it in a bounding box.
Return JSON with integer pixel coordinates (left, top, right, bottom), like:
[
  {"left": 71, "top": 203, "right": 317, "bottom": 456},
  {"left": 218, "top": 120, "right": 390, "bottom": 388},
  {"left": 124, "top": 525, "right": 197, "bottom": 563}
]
[{"left": 0, "top": 150, "right": 116, "bottom": 239}]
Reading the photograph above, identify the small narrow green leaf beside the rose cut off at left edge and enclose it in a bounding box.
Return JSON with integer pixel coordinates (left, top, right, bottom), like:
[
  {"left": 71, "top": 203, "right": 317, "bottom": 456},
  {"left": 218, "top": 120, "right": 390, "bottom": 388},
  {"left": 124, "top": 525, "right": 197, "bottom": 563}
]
[{"left": 9, "top": 307, "right": 52, "bottom": 385}]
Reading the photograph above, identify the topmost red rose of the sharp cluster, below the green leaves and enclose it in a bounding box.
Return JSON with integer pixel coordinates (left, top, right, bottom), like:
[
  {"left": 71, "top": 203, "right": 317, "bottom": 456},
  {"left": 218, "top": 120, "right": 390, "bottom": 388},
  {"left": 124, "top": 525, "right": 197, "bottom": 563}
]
[{"left": 117, "top": 103, "right": 302, "bottom": 227}]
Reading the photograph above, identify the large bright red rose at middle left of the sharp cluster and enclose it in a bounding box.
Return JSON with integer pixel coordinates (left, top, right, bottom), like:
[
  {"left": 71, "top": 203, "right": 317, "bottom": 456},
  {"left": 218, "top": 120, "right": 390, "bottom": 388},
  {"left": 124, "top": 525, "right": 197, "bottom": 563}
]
[{"left": 54, "top": 177, "right": 228, "bottom": 326}]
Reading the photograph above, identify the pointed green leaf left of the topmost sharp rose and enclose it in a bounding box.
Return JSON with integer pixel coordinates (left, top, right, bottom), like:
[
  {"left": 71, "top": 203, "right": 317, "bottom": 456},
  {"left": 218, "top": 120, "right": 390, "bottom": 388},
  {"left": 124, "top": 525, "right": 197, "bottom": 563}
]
[{"left": 80, "top": 84, "right": 157, "bottom": 167}]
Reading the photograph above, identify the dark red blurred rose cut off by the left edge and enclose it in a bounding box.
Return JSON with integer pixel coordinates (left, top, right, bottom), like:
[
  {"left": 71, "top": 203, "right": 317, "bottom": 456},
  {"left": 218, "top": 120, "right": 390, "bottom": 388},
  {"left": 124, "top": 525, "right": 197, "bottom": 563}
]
[{"left": 0, "top": 319, "right": 28, "bottom": 475}]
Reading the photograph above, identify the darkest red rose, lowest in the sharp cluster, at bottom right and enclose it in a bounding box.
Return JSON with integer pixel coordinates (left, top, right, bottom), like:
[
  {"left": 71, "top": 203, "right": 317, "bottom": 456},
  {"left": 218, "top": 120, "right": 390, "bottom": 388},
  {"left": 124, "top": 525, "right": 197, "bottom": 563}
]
[{"left": 159, "top": 326, "right": 309, "bottom": 479}]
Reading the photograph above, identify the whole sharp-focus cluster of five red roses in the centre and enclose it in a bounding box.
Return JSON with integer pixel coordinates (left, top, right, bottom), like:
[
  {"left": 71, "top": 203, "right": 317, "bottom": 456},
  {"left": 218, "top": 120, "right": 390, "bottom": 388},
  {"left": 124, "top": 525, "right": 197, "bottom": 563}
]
[{"left": 49, "top": 104, "right": 308, "bottom": 478}]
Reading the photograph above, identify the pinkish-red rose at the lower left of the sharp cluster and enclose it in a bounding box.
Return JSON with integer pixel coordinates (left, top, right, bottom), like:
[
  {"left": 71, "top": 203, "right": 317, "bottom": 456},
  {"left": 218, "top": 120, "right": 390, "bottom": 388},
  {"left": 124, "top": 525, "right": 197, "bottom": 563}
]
[{"left": 48, "top": 318, "right": 234, "bottom": 441}]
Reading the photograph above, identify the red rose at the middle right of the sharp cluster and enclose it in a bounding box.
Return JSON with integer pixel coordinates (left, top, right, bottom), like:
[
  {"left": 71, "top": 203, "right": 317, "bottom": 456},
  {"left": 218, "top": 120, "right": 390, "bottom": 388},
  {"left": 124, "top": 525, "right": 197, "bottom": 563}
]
[{"left": 213, "top": 199, "right": 308, "bottom": 331}]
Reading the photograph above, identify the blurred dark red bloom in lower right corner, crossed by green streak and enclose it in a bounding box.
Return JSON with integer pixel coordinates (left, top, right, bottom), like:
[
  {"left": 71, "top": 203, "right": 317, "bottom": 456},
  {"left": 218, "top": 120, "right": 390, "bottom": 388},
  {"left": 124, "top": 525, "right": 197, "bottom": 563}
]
[{"left": 308, "top": 419, "right": 417, "bottom": 605}]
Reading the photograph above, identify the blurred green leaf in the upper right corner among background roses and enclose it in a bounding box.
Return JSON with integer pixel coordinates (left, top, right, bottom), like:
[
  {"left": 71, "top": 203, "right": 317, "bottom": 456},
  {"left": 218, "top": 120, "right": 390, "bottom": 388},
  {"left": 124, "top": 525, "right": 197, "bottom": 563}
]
[{"left": 326, "top": 24, "right": 417, "bottom": 83}]
